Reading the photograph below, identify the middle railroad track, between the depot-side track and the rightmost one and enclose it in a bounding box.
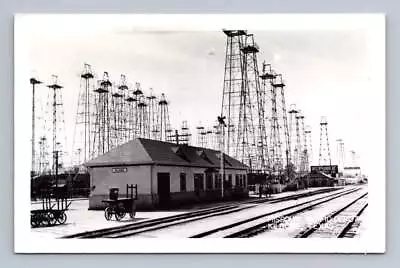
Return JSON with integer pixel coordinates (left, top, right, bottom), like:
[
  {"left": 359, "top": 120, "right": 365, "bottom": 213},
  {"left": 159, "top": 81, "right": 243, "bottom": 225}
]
[{"left": 191, "top": 188, "right": 361, "bottom": 238}]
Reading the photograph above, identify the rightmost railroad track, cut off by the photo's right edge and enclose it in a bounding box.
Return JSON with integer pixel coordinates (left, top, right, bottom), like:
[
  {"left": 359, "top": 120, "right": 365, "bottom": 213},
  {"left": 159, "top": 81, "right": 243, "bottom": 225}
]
[{"left": 296, "top": 193, "right": 368, "bottom": 238}]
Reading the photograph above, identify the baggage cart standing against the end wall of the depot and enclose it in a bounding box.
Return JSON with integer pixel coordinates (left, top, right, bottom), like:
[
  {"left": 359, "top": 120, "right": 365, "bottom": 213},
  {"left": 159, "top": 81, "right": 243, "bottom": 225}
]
[{"left": 102, "top": 184, "right": 137, "bottom": 221}]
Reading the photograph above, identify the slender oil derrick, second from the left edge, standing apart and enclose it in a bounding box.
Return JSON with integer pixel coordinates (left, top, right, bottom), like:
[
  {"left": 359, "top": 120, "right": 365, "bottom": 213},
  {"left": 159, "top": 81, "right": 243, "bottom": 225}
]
[{"left": 47, "top": 75, "right": 65, "bottom": 178}]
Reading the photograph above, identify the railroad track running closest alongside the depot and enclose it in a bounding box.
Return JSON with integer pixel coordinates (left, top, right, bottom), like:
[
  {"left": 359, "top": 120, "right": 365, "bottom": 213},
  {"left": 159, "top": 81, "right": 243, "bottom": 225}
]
[{"left": 63, "top": 188, "right": 342, "bottom": 238}]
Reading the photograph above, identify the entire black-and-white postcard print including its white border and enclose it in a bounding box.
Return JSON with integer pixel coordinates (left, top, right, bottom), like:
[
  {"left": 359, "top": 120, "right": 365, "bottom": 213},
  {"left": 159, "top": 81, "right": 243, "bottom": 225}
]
[{"left": 14, "top": 14, "right": 386, "bottom": 253}]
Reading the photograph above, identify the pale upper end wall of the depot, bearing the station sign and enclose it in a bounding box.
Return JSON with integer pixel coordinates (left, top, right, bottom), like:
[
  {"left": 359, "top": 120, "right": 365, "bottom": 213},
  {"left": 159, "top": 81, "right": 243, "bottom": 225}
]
[{"left": 90, "top": 166, "right": 151, "bottom": 195}]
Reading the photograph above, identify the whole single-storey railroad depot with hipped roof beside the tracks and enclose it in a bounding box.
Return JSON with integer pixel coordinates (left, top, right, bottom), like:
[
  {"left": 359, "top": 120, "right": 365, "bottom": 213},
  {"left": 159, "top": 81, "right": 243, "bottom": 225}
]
[{"left": 85, "top": 138, "right": 248, "bottom": 209}]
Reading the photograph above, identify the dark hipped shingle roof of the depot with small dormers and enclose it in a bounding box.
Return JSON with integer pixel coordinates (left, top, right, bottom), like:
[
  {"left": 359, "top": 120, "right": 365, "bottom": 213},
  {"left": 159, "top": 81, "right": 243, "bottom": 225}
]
[{"left": 84, "top": 138, "right": 248, "bottom": 169}]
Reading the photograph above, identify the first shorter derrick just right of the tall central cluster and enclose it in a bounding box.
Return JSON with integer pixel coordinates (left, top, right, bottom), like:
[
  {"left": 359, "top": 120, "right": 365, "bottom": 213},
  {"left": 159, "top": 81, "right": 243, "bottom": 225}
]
[{"left": 288, "top": 104, "right": 300, "bottom": 170}]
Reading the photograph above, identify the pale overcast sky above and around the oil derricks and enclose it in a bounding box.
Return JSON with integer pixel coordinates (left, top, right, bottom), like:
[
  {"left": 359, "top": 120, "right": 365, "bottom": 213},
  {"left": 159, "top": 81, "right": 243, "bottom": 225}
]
[{"left": 18, "top": 14, "right": 384, "bottom": 178}]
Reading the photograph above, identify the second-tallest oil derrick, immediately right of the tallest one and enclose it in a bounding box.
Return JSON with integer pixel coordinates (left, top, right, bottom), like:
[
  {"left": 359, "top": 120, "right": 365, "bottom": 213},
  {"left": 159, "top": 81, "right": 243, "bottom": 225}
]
[{"left": 239, "top": 34, "right": 268, "bottom": 172}]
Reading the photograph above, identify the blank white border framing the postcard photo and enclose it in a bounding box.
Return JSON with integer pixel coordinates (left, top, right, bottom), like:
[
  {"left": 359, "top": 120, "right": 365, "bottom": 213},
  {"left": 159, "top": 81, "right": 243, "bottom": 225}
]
[{"left": 14, "top": 13, "right": 386, "bottom": 253}]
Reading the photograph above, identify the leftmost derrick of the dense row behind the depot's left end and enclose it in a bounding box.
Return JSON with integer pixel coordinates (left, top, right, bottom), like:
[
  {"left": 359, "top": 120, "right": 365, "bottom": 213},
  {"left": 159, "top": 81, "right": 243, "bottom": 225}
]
[{"left": 72, "top": 63, "right": 94, "bottom": 165}]
